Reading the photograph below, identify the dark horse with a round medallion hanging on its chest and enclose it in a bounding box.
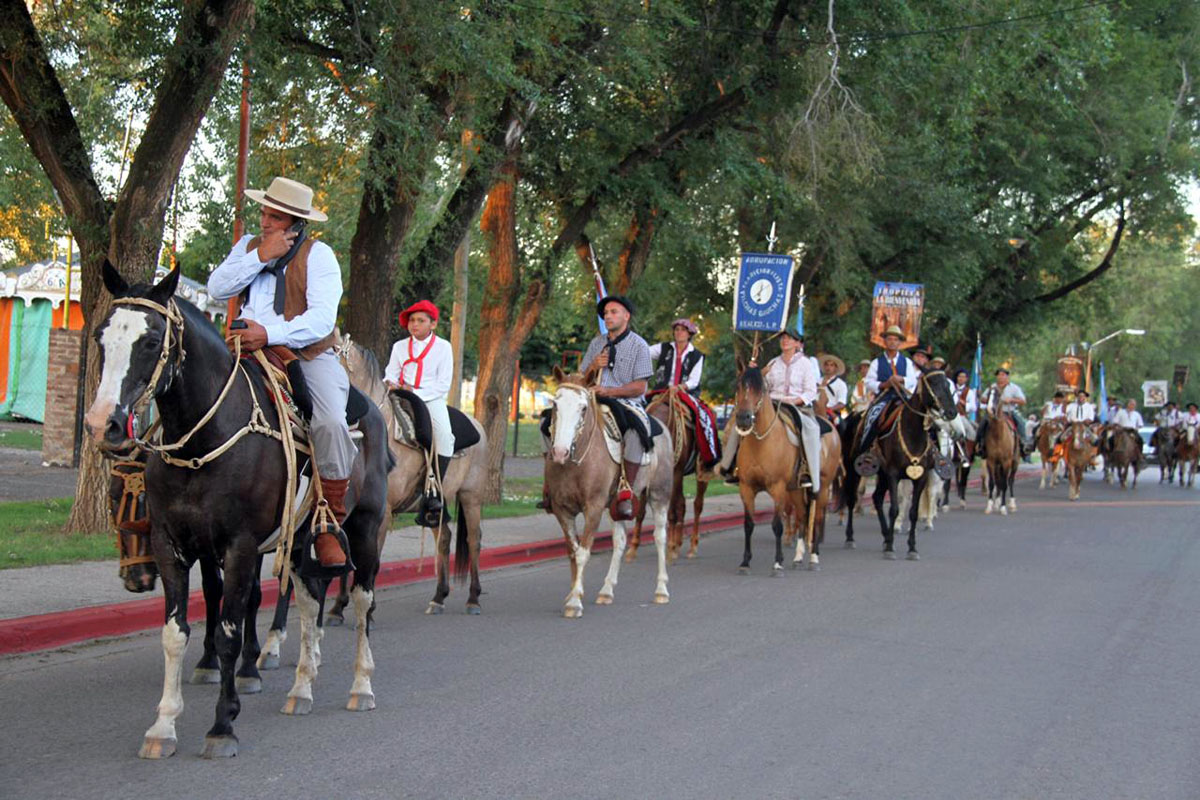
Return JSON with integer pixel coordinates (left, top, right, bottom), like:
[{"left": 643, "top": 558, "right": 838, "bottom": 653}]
[{"left": 842, "top": 369, "right": 962, "bottom": 561}]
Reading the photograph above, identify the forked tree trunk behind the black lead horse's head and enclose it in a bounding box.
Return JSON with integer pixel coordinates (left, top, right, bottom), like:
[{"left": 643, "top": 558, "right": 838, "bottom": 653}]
[{"left": 0, "top": 0, "right": 254, "bottom": 533}]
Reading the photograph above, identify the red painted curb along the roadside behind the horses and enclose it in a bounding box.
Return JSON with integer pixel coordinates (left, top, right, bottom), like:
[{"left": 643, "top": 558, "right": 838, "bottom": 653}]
[{"left": 0, "top": 511, "right": 772, "bottom": 655}]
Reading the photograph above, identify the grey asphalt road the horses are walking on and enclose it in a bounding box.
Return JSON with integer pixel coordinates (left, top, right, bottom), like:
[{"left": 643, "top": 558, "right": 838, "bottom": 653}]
[{"left": 0, "top": 475, "right": 1200, "bottom": 800}]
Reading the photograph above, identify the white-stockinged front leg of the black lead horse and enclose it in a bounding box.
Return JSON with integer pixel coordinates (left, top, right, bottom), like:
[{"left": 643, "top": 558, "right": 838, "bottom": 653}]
[{"left": 138, "top": 560, "right": 191, "bottom": 758}]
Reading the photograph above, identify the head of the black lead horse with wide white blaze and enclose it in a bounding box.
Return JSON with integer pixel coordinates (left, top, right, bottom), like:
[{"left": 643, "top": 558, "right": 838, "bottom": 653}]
[{"left": 84, "top": 259, "right": 179, "bottom": 451}]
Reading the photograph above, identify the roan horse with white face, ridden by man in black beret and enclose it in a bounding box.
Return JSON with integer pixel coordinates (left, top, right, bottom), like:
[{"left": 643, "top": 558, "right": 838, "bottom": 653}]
[{"left": 544, "top": 366, "right": 674, "bottom": 619}]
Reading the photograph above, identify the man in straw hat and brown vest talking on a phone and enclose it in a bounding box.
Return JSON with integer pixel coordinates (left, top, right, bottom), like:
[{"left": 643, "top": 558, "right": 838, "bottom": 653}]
[{"left": 209, "top": 178, "right": 355, "bottom": 567}]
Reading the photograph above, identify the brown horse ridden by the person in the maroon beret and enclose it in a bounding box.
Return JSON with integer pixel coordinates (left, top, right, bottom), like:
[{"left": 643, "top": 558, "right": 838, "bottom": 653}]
[{"left": 625, "top": 385, "right": 710, "bottom": 564}]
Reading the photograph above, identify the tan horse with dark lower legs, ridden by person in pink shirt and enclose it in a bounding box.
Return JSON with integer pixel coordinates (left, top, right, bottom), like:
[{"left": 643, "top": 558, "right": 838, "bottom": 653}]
[{"left": 733, "top": 365, "right": 820, "bottom": 575}]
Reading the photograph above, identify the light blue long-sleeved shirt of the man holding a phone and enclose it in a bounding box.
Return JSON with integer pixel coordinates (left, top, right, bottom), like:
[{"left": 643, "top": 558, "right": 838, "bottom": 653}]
[{"left": 209, "top": 234, "right": 342, "bottom": 349}]
